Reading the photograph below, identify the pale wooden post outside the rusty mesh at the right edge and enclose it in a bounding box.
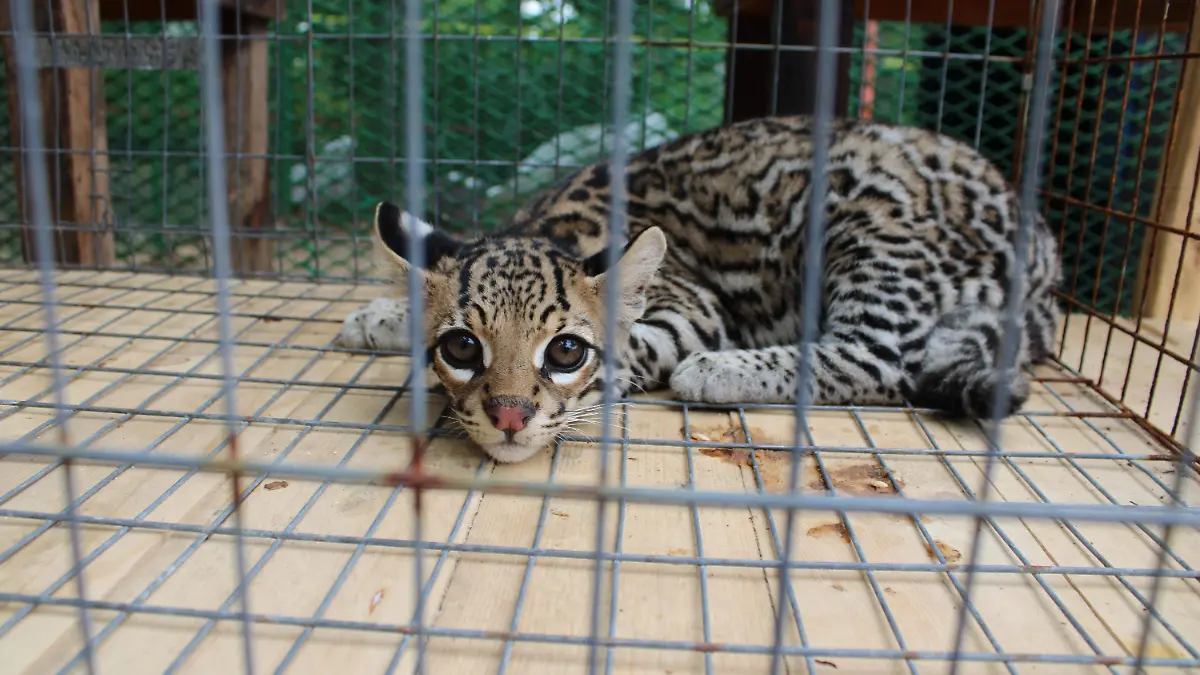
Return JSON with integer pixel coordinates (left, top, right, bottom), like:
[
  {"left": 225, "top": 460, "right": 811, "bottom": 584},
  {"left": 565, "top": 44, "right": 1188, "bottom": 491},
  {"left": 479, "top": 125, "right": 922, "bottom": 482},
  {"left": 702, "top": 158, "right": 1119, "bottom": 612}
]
[{"left": 1134, "top": 11, "right": 1200, "bottom": 321}]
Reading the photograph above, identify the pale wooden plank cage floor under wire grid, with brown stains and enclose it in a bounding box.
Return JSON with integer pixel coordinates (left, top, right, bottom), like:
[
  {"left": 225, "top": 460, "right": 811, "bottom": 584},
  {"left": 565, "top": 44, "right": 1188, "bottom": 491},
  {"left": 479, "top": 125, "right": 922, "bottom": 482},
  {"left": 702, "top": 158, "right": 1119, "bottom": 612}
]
[{"left": 0, "top": 270, "right": 1200, "bottom": 674}]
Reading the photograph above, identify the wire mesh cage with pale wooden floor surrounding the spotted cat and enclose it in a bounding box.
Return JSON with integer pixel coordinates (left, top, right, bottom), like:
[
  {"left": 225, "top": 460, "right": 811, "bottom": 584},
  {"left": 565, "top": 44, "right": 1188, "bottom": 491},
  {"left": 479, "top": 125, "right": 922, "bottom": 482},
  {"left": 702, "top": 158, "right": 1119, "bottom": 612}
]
[{"left": 0, "top": 0, "right": 1200, "bottom": 674}]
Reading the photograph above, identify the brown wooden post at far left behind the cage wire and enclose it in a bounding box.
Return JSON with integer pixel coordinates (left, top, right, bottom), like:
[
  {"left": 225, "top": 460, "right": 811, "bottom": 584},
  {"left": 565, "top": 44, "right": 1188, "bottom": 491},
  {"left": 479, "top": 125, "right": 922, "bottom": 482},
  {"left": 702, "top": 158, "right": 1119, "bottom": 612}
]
[{"left": 0, "top": 0, "right": 115, "bottom": 267}]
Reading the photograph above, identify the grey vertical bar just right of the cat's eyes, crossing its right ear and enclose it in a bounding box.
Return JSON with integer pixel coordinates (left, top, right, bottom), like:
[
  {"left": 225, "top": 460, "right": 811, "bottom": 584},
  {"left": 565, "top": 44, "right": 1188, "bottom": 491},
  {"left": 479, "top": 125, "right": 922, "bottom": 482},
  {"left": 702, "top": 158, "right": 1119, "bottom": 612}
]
[{"left": 588, "top": 0, "right": 634, "bottom": 675}]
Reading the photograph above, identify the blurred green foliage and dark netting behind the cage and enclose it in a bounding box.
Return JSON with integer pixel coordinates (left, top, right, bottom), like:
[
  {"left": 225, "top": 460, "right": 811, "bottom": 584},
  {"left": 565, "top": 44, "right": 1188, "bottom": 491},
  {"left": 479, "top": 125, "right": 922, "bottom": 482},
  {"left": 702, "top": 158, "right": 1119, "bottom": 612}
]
[{"left": 0, "top": 0, "right": 1183, "bottom": 310}]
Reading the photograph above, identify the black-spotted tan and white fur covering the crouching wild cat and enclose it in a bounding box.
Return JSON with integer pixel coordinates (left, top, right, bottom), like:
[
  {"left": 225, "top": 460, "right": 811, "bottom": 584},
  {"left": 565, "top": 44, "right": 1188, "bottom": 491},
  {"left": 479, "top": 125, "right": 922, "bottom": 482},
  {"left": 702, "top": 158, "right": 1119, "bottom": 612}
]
[{"left": 342, "top": 118, "right": 1061, "bottom": 461}]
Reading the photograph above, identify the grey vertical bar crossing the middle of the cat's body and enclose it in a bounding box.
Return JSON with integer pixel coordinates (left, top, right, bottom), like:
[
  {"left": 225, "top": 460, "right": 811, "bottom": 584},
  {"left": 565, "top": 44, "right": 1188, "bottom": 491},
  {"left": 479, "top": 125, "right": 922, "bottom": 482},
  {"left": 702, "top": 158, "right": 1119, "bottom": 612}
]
[{"left": 770, "top": 0, "right": 841, "bottom": 675}]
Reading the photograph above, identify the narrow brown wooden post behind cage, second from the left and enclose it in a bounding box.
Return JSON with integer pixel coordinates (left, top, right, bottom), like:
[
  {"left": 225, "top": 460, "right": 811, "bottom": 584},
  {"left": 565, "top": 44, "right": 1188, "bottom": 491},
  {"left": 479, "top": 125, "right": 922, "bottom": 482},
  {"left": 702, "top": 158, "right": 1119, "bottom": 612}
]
[{"left": 221, "top": 12, "right": 275, "bottom": 273}]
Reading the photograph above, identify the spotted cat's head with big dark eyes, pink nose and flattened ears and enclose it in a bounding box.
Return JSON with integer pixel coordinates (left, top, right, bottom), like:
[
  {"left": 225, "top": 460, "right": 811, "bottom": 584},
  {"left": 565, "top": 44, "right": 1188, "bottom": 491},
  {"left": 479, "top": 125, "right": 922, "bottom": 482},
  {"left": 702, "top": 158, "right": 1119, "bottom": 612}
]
[{"left": 376, "top": 203, "right": 666, "bottom": 462}]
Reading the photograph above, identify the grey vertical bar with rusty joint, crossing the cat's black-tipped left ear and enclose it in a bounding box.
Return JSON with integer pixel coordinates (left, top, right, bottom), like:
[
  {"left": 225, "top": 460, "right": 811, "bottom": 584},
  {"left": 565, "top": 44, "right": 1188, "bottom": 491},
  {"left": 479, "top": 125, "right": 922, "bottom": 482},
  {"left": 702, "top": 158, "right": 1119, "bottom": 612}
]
[{"left": 404, "top": 0, "right": 428, "bottom": 675}]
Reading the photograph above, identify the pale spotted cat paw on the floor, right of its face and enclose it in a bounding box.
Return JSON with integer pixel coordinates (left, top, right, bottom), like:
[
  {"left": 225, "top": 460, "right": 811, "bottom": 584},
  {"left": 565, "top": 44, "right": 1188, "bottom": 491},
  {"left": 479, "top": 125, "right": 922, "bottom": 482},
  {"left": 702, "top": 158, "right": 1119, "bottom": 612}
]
[{"left": 671, "top": 351, "right": 794, "bottom": 404}]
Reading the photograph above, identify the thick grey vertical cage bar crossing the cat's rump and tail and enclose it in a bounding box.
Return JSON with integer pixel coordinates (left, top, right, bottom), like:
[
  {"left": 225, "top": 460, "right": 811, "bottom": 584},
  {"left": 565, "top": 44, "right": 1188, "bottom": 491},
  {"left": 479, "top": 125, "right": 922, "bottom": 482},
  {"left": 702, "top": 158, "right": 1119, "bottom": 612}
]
[{"left": 949, "top": 0, "right": 1060, "bottom": 675}]
